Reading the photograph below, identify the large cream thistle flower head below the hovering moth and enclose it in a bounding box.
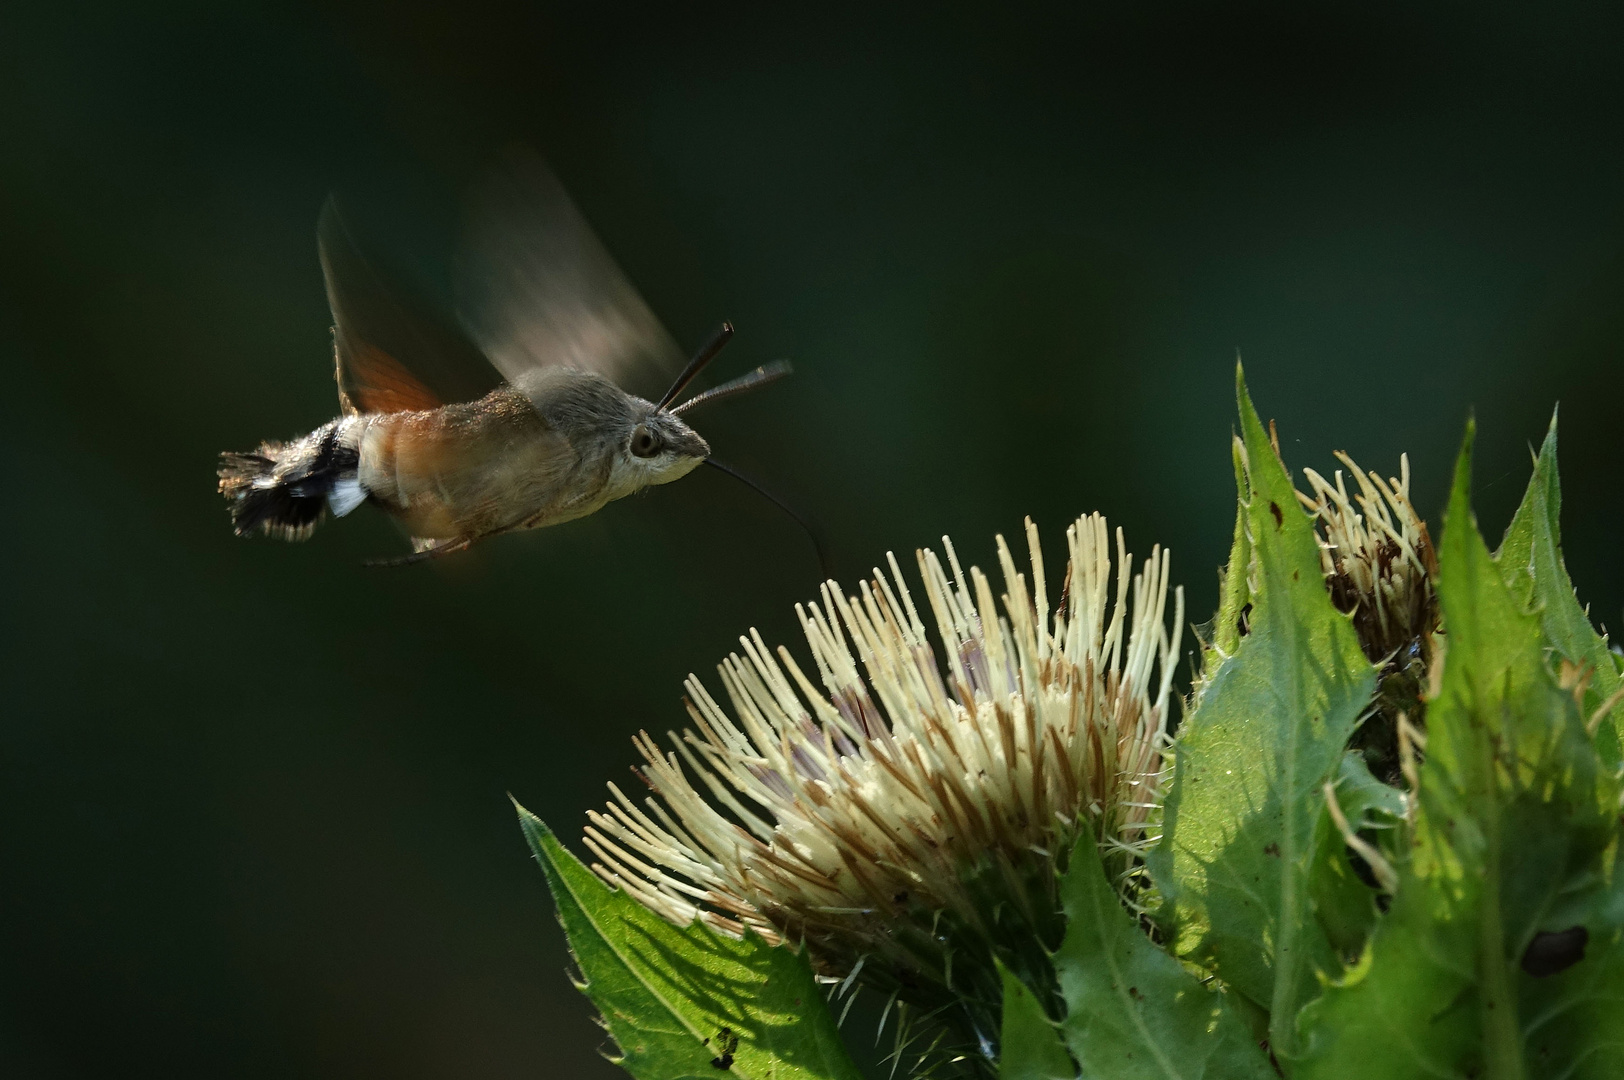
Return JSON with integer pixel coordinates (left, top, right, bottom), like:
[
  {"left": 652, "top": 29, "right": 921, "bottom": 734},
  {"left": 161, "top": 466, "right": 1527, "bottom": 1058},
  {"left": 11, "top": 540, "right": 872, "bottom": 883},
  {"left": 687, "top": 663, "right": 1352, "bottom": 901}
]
[{"left": 586, "top": 515, "right": 1184, "bottom": 1061}]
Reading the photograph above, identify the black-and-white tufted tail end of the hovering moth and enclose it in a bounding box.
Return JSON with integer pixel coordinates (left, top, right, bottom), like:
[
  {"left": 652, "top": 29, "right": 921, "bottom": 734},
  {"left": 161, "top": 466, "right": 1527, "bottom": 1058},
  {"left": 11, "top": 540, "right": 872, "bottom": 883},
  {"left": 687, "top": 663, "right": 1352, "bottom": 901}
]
[{"left": 219, "top": 421, "right": 359, "bottom": 541}]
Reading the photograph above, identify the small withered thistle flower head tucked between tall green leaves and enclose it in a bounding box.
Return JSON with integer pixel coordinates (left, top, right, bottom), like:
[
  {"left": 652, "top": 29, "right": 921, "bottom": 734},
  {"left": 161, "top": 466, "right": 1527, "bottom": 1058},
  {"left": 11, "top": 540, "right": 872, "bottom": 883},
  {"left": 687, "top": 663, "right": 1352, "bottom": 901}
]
[{"left": 1298, "top": 451, "right": 1439, "bottom": 784}]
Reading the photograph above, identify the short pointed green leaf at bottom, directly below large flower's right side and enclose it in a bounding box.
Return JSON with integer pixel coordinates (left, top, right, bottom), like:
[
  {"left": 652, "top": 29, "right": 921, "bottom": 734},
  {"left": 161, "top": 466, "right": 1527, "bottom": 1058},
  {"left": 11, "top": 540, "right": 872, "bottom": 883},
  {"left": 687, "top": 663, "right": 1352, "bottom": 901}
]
[{"left": 1052, "top": 830, "right": 1275, "bottom": 1080}]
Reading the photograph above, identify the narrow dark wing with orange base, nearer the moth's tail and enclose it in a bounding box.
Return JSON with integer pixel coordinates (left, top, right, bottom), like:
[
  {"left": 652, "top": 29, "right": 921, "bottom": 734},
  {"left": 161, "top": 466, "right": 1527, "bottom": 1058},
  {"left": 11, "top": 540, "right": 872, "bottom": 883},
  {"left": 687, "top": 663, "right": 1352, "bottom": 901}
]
[{"left": 317, "top": 198, "right": 502, "bottom": 413}]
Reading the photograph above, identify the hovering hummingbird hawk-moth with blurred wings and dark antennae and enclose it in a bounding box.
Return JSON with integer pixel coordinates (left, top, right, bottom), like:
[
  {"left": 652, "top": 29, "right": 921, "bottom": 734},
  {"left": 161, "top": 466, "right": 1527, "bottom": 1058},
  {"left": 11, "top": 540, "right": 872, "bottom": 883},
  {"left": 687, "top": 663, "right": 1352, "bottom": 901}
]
[{"left": 219, "top": 156, "right": 799, "bottom": 562}]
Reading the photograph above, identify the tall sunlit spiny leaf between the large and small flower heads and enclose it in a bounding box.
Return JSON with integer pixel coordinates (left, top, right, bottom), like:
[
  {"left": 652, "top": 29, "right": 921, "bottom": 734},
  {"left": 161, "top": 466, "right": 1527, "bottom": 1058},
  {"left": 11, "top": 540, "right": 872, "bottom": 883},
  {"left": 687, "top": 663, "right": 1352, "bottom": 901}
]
[{"left": 1150, "top": 363, "right": 1376, "bottom": 1049}]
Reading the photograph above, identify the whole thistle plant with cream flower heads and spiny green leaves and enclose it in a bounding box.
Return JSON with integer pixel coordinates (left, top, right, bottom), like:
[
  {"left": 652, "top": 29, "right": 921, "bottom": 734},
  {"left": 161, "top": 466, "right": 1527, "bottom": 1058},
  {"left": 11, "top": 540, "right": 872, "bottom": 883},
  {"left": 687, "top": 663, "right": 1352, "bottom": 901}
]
[{"left": 520, "top": 377, "right": 1624, "bottom": 1080}]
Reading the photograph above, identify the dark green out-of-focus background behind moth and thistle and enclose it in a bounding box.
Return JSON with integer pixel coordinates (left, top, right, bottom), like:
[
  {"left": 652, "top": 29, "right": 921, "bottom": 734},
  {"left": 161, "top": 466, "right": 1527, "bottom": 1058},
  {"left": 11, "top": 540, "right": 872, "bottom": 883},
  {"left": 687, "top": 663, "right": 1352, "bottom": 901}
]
[{"left": 0, "top": 0, "right": 1624, "bottom": 1078}]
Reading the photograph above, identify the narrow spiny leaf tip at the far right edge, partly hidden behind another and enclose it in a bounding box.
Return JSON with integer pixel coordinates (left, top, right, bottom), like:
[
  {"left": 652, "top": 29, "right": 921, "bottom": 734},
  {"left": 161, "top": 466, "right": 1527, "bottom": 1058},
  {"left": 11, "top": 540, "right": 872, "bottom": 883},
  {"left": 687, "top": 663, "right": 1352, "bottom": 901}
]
[{"left": 1496, "top": 404, "right": 1624, "bottom": 770}]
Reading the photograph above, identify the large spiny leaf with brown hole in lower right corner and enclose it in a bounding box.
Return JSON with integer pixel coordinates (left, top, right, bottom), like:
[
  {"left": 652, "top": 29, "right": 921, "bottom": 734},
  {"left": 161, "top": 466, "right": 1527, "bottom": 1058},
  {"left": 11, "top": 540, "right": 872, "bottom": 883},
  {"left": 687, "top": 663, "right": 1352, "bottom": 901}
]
[{"left": 1289, "top": 427, "right": 1624, "bottom": 1080}]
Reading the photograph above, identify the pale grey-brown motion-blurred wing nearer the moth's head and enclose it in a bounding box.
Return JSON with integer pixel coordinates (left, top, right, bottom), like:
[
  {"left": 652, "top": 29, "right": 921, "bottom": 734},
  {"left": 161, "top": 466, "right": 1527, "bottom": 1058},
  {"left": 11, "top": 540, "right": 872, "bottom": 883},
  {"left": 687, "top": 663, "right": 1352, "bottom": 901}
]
[{"left": 456, "top": 153, "right": 684, "bottom": 400}]
